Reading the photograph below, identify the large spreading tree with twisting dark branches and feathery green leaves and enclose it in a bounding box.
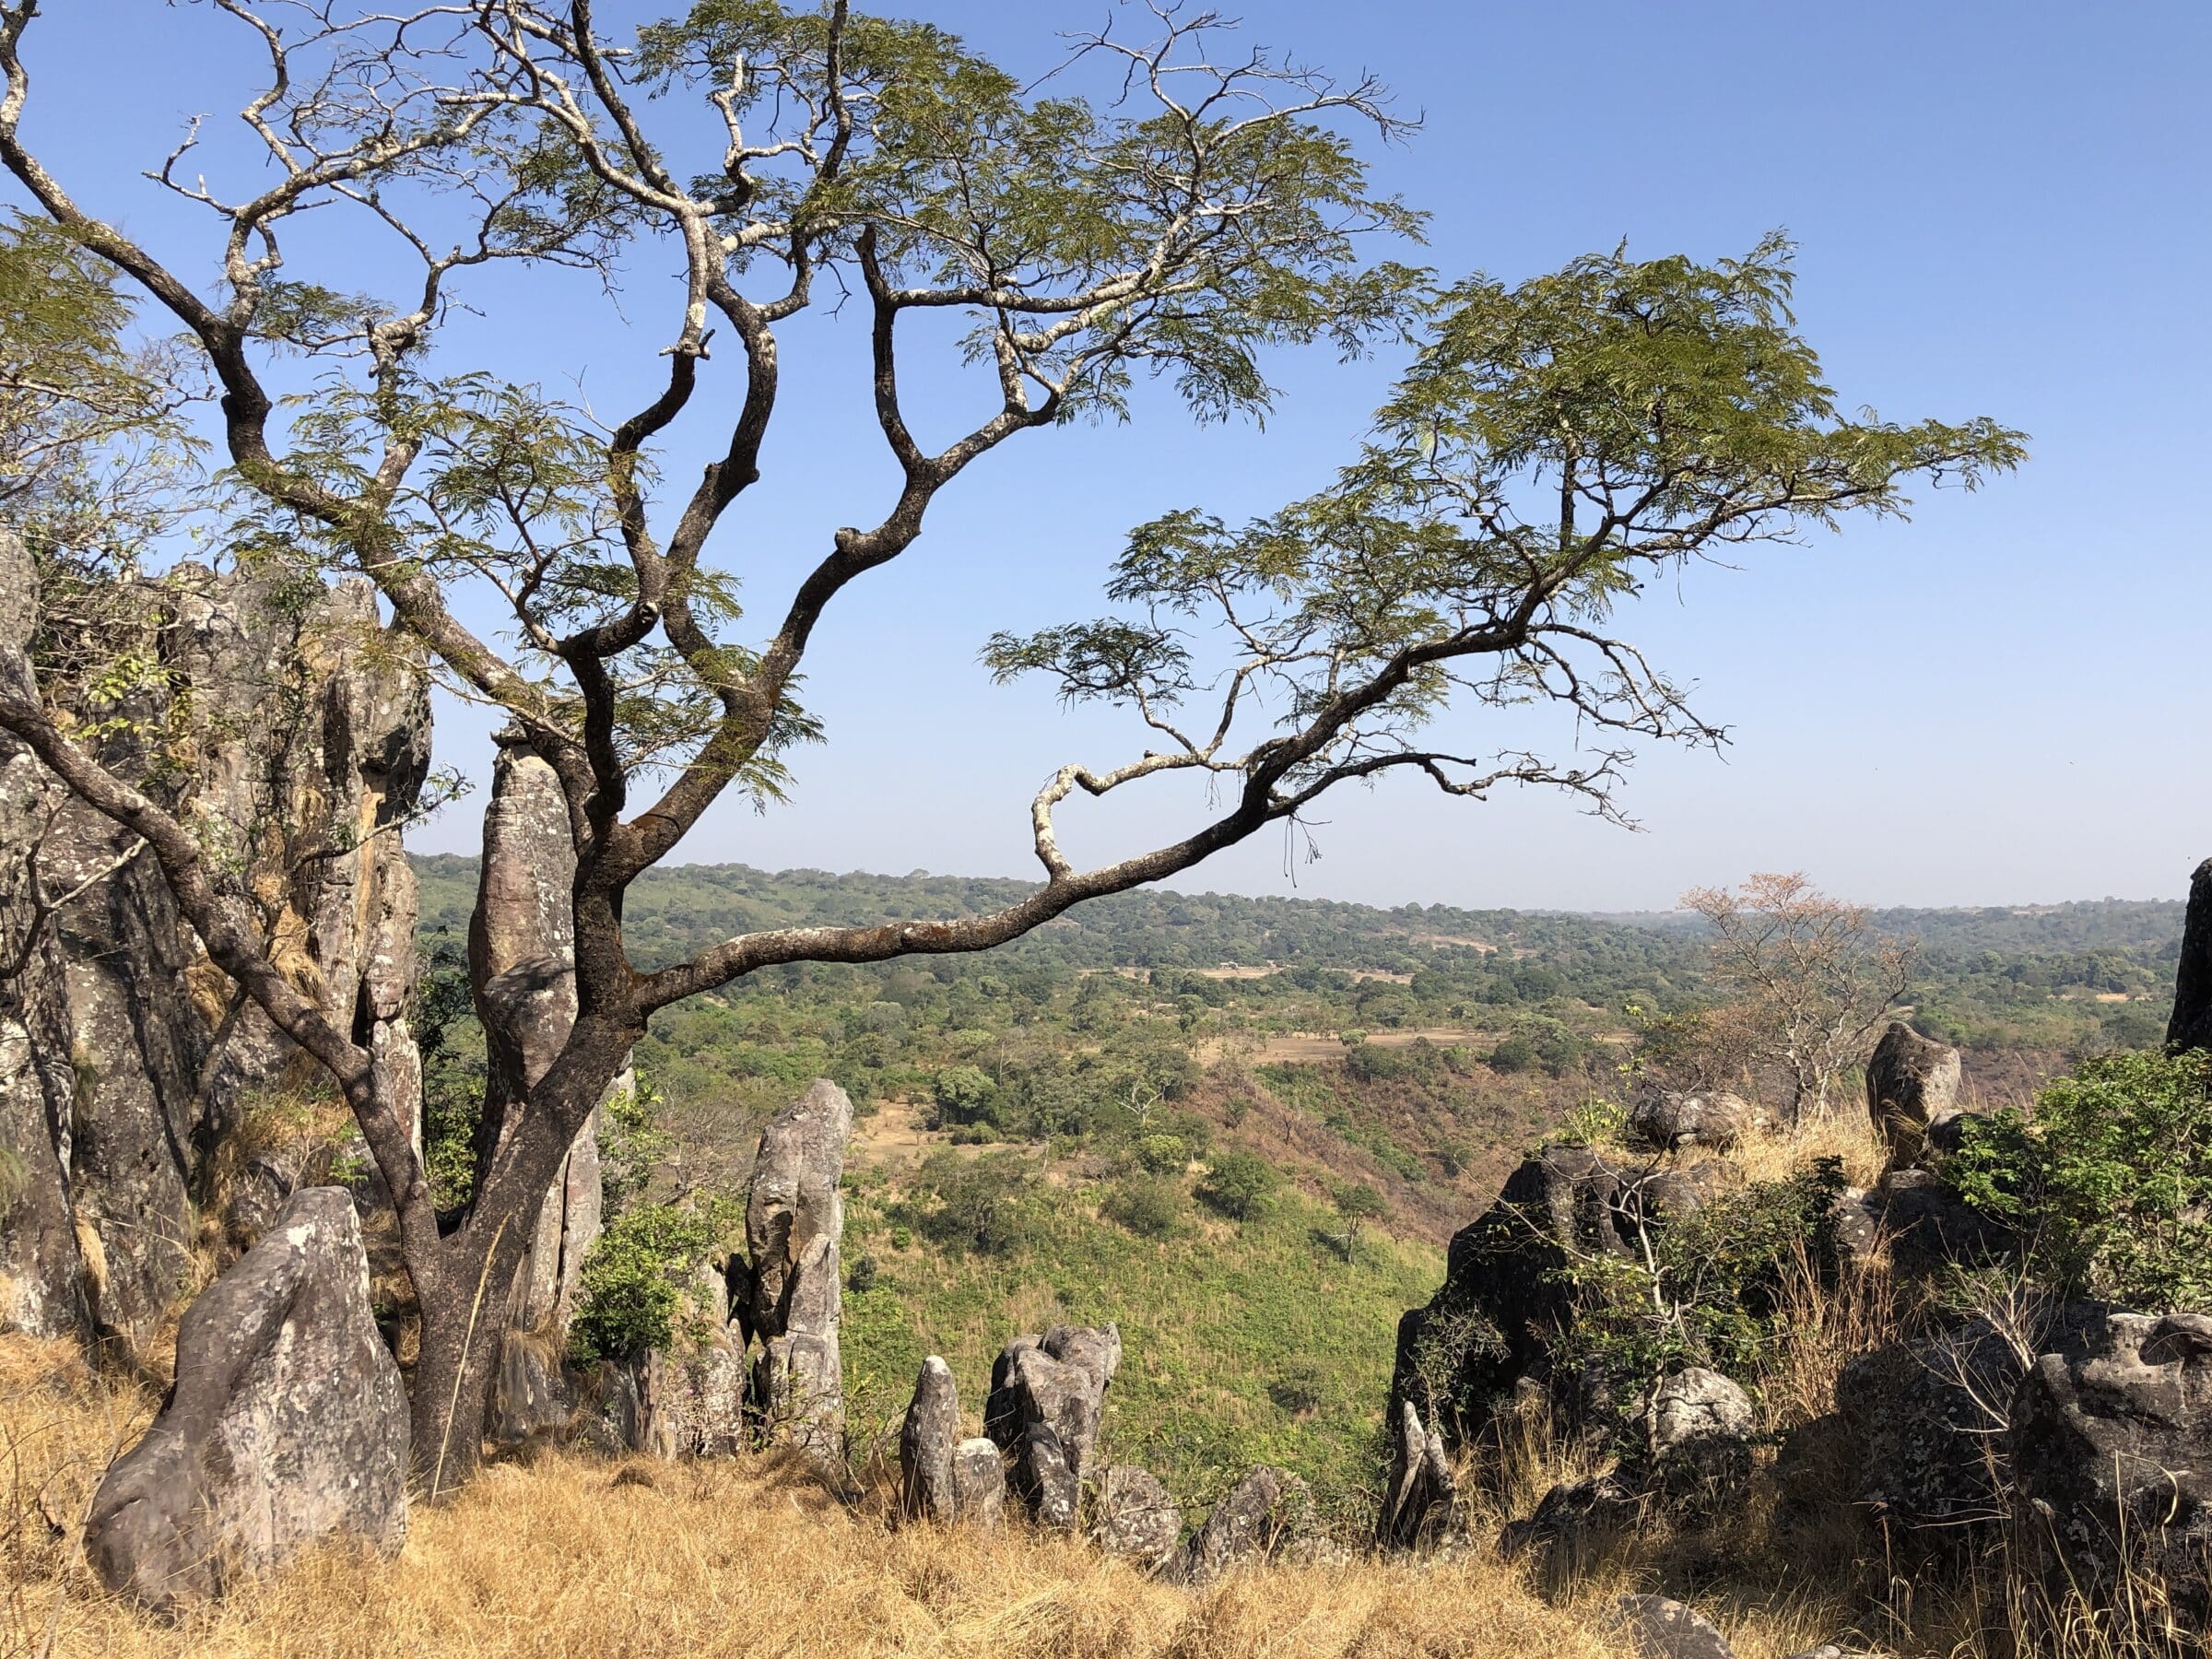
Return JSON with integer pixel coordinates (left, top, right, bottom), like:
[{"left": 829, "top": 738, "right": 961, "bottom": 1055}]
[{"left": 0, "top": 0, "right": 2018, "bottom": 1487}]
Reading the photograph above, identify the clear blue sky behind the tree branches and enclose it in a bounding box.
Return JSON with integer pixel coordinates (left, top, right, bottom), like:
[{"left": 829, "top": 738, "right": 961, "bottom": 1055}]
[{"left": 8, "top": 0, "right": 2212, "bottom": 909}]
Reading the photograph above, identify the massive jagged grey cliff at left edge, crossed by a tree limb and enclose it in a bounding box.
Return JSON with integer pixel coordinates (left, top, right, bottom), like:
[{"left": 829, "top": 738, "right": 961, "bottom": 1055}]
[{"left": 0, "top": 544, "right": 429, "bottom": 1354}]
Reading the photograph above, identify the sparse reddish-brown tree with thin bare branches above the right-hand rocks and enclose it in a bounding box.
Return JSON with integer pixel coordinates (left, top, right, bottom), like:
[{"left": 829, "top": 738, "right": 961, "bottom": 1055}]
[{"left": 1681, "top": 874, "right": 1915, "bottom": 1122}]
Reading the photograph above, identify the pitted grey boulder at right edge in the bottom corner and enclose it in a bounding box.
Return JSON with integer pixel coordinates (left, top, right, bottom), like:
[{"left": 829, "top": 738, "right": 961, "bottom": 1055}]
[{"left": 2006, "top": 1312, "right": 2212, "bottom": 1639}]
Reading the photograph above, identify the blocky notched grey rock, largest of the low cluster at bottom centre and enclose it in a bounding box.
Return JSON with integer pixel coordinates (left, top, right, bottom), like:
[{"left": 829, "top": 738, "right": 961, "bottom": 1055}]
[{"left": 982, "top": 1325, "right": 1122, "bottom": 1526}]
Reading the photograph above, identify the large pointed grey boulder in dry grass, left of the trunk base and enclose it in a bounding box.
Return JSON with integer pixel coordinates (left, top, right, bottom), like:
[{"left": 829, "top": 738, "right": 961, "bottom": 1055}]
[{"left": 84, "top": 1188, "right": 407, "bottom": 1610}]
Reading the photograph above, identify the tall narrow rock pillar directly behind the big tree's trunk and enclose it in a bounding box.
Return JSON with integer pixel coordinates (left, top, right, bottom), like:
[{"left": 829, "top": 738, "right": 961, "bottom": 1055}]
[{"left": 469, "top": 732, "right": 610, "bottom": 1444}]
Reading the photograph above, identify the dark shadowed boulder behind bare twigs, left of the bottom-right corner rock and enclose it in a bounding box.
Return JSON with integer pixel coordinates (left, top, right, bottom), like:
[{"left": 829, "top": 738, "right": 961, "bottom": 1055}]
[{"left": 1836, "top": 1307, "right": 2095, "bottom": 1553}]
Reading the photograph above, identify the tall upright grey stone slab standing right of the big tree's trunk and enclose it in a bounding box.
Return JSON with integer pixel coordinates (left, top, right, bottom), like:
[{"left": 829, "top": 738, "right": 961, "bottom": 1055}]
[{"left": 746, "top": 1077, "right": 852, "bottom": 1458}]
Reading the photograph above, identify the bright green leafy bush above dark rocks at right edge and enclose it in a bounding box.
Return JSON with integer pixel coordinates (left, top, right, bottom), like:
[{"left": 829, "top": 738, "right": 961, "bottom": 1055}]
[{"left": 1942, "top": 1051, "right": 2212, "bottom": 1312}]
